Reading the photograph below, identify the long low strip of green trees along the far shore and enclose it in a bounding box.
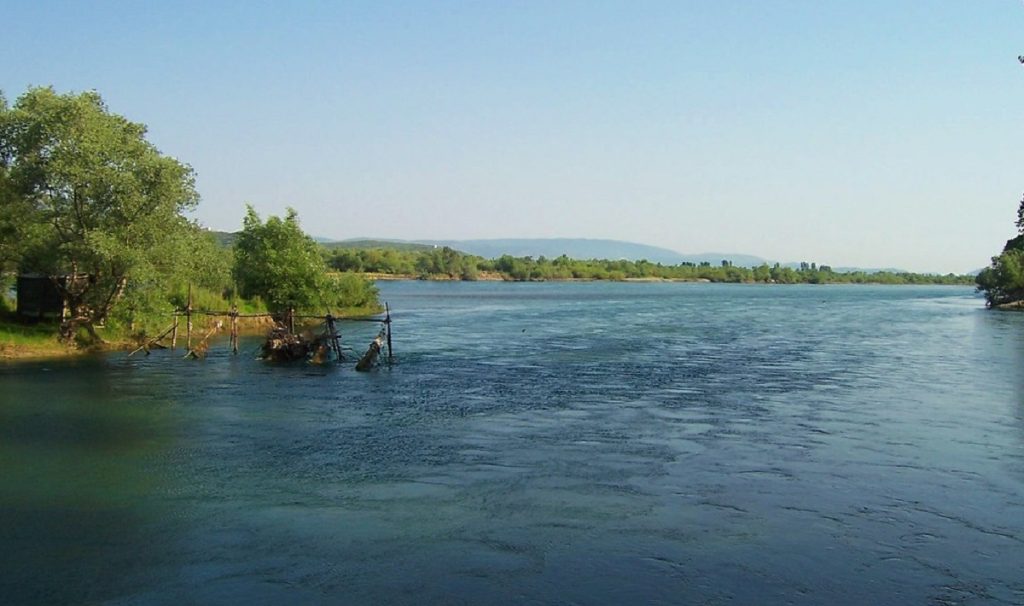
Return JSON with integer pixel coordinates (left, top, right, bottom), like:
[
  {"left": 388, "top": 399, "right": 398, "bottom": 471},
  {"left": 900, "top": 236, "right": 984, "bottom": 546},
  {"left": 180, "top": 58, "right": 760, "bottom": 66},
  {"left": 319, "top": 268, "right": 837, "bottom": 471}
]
[{"left": 325, "top": 247, "right": 974, "bottom": 285}]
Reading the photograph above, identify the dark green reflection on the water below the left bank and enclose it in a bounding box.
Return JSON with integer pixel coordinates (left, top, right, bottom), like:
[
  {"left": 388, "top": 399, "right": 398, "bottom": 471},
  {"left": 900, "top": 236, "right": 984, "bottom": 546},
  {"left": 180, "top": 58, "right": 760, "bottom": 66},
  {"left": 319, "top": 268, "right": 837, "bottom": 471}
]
[{"left": 0, "top": 360, "right": 182, "bottom": 604}]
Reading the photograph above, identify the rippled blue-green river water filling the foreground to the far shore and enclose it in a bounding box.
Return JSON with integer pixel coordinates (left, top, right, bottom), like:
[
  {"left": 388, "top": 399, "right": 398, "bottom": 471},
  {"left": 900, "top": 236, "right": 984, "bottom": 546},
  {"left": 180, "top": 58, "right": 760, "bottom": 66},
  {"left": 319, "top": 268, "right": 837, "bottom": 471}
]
[{"left": 0, "top": 283, "right": 1024, "bottom": 605}]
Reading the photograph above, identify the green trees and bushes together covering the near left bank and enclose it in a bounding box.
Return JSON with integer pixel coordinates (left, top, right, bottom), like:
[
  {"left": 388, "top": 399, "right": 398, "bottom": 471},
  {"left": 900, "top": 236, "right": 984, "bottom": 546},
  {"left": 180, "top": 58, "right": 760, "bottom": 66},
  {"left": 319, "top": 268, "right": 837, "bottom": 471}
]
[{"left": 0, "top": 82, "right": 378, "bottom": 352}]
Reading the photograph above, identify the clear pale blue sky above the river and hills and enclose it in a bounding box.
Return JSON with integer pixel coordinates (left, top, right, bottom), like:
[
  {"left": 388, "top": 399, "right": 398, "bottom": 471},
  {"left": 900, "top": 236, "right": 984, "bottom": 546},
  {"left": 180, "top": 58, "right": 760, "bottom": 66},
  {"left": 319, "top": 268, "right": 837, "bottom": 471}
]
[{"left": 0, "top": 0, "right": 1024, "bottom": 272}]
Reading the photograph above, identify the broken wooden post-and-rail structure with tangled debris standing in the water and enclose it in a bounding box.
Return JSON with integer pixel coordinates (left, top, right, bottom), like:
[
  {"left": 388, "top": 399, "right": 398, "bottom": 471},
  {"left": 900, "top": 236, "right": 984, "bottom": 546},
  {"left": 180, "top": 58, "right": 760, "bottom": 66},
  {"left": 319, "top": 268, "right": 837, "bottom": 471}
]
[{"left": 128, "top": 287, "right": 394, "bottom": 372}]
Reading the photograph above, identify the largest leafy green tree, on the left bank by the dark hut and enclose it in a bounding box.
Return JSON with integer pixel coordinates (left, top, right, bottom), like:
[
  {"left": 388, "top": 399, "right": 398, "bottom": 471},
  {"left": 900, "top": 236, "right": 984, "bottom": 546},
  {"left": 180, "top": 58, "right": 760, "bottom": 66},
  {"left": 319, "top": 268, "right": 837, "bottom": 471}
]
[{"left": 0, "top": 87, "right": 199, "bottom": 339}]
